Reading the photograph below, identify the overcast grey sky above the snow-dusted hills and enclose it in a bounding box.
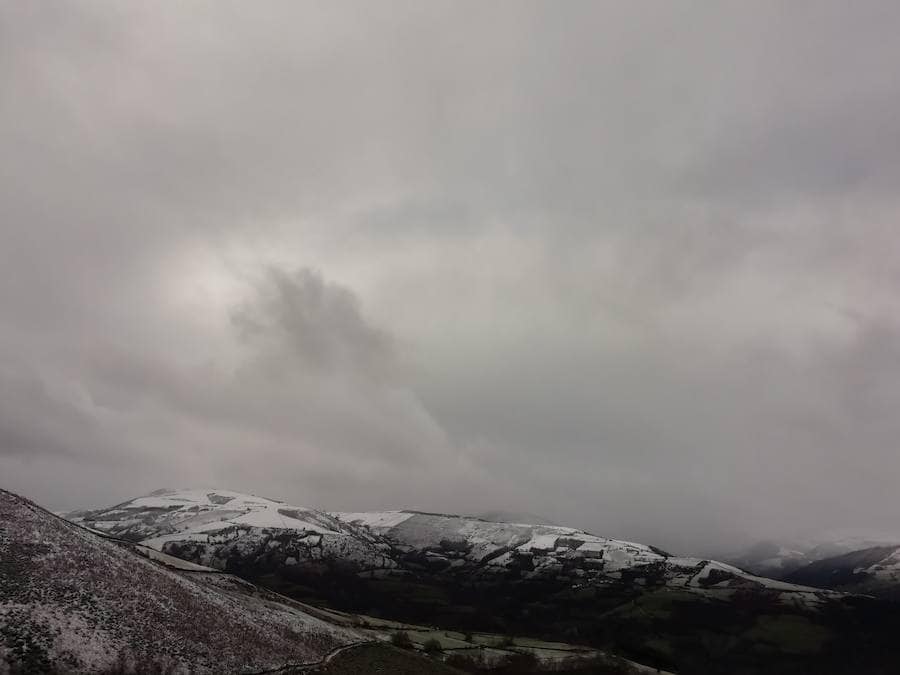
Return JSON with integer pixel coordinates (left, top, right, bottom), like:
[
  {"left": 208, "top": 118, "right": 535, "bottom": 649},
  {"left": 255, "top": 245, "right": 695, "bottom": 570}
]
[{"left": 0, "top": 0, "right": 900, "bottom": 552}]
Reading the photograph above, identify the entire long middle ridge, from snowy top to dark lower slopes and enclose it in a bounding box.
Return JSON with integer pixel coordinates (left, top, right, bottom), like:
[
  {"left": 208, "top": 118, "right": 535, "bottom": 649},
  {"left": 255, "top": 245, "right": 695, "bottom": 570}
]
[{"left": 67, "top": 490, "right": 900, "bottom": 674}]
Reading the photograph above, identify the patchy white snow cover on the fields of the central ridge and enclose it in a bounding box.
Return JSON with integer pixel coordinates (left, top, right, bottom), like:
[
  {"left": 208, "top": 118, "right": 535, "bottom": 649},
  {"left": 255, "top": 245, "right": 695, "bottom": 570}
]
[{"left": 72, "top": 490, "right": 836, "bottom": 595}]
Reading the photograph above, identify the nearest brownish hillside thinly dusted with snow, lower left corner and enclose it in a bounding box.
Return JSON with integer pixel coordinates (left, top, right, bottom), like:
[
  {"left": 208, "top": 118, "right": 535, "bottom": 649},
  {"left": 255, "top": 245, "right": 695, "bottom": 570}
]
[{"left": 0, "top": 490, "right": 360, "bottom": 673}]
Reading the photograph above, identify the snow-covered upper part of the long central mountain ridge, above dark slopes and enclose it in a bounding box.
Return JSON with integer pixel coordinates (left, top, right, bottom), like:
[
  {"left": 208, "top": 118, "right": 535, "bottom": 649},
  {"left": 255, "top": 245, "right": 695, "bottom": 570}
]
[{"left": 71, "top": 490, "right": 821, "bottom": 603}]
